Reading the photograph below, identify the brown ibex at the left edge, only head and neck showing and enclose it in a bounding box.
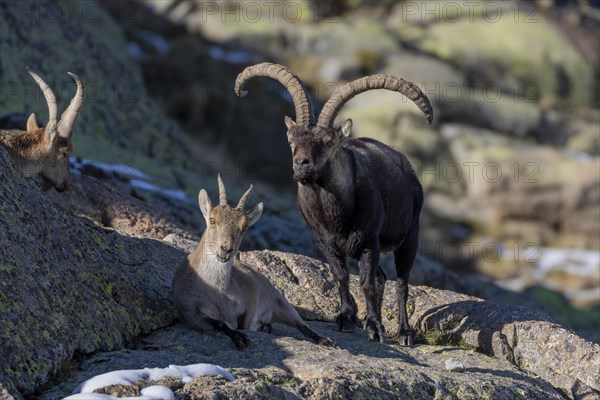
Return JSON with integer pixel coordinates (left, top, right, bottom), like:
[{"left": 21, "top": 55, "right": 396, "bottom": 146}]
[{"left": 0, "top": 68, "right": 84, "bottom": 192}]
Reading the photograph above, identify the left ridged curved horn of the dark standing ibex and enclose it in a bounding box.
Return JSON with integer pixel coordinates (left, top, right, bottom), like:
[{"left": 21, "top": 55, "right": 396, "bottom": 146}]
[{"left": 235, "top": 63, "right": 315, "bottom": 125}]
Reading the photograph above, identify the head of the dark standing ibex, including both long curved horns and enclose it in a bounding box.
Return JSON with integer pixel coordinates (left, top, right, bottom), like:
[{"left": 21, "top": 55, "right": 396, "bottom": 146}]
[{"left": 235, "top": 63, "right": 433, "bottom": 184}]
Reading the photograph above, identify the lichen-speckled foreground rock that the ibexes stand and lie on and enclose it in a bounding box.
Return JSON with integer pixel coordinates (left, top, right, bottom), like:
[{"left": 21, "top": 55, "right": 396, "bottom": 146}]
[{"left": 0, "top": 145, "right": 600, "bottom": 399}]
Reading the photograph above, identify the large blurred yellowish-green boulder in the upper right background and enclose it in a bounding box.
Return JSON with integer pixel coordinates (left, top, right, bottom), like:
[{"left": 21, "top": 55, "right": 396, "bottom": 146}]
[{"left": 387, "top": 1, "right": 595, "bottom": 106}]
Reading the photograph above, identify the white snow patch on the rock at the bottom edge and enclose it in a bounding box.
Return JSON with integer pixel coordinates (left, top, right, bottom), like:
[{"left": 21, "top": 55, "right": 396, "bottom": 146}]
[{"left": 65, "top": 364, "right": 235, "bottom": 400}]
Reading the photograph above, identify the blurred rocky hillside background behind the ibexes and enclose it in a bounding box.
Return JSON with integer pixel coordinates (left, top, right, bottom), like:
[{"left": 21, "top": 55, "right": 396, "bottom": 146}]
[{"left": 0, "top": 0, "right": 600, "bottom": 342}]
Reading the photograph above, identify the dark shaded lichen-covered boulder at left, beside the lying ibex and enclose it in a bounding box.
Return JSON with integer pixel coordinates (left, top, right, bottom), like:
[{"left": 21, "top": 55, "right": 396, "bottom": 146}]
[{"left": 0, "top": 148, "right": 184, "bottom": 398}]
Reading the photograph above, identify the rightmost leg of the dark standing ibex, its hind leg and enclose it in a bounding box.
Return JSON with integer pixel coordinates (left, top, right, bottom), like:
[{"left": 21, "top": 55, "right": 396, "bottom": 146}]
[{"left": 394, "top": 219, "right": 419, "bottom": 346}]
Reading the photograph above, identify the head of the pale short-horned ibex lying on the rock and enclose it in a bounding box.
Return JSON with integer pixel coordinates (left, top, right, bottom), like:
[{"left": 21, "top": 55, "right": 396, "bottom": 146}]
[{"left": 198, "top": 175, "right": 263, "bottom": 263}]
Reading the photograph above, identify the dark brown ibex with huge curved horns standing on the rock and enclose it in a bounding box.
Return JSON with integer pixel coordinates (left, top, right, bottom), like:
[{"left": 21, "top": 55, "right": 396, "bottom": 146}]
[{"left": 235, "top": 63, "right": 433, "bottom": 345}]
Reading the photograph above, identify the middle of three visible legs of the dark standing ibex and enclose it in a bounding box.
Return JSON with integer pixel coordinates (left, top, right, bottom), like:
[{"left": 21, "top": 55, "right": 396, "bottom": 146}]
[{"left": 358, "top": 239, "right": 385, "bottom": 342}]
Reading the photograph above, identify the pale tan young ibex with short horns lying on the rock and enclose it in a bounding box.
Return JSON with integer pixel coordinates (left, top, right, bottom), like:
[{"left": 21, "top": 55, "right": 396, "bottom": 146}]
[{"left": 172, "top": 176, "right": 334, "bottom": 349}]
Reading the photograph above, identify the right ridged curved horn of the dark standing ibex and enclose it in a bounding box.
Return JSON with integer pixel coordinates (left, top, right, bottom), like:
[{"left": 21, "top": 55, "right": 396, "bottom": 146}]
[{"left": 317, "top": 74, "right": 433, "bottom": 128}]
